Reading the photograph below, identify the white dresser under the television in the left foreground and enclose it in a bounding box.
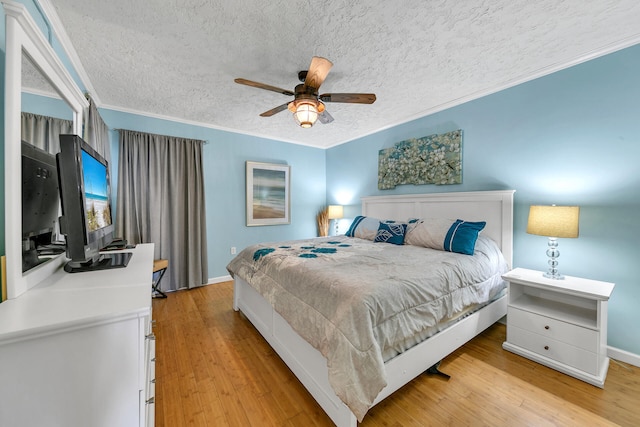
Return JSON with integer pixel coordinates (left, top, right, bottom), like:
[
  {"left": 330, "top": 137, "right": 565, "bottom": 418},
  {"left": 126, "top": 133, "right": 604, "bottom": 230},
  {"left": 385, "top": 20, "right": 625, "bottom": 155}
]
[{"left": 0, "top": 244, "right": 155, "bottom": 427}]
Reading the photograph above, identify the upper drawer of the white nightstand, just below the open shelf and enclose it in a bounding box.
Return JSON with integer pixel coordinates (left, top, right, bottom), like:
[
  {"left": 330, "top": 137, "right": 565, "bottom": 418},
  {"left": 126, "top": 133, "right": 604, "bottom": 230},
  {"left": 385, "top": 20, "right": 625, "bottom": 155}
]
[{"left": 507, "top": 307, "right": 599, "bottom": 353}]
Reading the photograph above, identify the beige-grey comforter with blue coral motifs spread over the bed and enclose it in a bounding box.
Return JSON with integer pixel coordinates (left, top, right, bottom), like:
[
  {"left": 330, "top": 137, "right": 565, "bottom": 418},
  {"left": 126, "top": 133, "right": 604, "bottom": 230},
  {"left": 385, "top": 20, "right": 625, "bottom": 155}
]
[{"left": 227, "top": 236, "right": 507, "bottom": 421}]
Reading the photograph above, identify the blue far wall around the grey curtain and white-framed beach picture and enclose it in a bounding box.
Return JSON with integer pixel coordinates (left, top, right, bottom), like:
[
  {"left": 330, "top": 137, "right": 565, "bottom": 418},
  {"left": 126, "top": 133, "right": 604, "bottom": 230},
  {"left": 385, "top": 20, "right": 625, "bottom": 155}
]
[{"left": 100, "top": 109, "right": 326, "bottom": 278}]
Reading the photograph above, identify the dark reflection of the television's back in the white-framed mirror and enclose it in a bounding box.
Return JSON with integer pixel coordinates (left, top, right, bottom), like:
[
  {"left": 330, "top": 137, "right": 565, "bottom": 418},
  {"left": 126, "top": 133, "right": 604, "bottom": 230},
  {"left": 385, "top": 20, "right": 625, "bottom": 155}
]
[{"left": 22, "top": 141, "right": 61, "bottom": 273}]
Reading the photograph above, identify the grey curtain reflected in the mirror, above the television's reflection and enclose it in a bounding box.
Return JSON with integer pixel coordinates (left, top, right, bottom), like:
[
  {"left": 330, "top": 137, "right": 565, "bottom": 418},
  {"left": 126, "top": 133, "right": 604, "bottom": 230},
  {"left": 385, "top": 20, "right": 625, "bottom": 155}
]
[{"left": 21, "top": 113, "right": 73, "bottom": 154}]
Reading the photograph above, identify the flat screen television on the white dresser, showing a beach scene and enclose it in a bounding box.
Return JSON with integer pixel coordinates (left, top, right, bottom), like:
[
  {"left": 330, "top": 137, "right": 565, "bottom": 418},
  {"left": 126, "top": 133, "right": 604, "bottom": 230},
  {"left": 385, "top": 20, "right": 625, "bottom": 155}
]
[{"left": 56, "top": 135, "right": 132, "bottom": 273}]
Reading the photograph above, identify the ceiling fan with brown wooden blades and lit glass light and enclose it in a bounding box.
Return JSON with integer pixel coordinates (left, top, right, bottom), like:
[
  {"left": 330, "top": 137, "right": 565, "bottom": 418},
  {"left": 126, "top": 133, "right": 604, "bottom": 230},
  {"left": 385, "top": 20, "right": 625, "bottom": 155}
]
[{"left": 234, "top": 56, "right": 376, "bottom": 128}]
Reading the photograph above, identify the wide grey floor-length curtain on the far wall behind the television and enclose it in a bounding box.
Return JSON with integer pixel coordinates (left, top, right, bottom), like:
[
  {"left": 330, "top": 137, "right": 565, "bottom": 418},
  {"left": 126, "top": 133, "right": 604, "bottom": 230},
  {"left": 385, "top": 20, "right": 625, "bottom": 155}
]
[{"left": 116, "top": 130, "right": 208, "bottom": 291}]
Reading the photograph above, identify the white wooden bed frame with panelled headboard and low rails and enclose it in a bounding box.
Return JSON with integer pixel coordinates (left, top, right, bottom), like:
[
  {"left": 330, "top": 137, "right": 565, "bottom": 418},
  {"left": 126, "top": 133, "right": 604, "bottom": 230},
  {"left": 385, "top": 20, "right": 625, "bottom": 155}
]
[{"left": 233, "top": 190, "right": 514, "bottom": 427}]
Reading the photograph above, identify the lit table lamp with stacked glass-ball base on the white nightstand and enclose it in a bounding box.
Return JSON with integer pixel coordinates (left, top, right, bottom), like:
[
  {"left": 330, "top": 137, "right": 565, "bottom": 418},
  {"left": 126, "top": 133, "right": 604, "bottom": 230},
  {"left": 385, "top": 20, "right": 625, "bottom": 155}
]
[{"left": 527, "top": 205, "right": 580, "bottom": 280}]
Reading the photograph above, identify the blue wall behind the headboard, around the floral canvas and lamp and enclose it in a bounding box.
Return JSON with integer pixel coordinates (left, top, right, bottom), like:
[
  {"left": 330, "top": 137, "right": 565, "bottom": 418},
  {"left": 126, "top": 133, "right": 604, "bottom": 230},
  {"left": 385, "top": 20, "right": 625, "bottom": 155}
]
[{"left": 327, "top": 45, "right": 640, "bottom": 354}]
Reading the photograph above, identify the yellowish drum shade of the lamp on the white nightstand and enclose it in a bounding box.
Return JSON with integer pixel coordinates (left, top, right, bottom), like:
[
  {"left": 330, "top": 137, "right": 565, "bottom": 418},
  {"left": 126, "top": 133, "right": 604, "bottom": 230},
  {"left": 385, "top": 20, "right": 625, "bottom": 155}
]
[{"left": 527, "top": 205, "right": 580, "bottom": 238}]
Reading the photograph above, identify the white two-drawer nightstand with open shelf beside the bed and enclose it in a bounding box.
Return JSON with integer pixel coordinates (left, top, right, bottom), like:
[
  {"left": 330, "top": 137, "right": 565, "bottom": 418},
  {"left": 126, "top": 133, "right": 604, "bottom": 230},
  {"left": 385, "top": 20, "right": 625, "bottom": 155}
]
[{"left": 502, "top": 268, "right": 614, "bottom": 388}]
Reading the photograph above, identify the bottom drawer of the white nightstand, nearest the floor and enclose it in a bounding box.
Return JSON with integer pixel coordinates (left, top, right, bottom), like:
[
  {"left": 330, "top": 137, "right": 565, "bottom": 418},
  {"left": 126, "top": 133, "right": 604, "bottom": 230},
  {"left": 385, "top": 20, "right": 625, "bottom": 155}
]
[{"left": 507, "top": 324, "right": 599, "bottom": 375}]
